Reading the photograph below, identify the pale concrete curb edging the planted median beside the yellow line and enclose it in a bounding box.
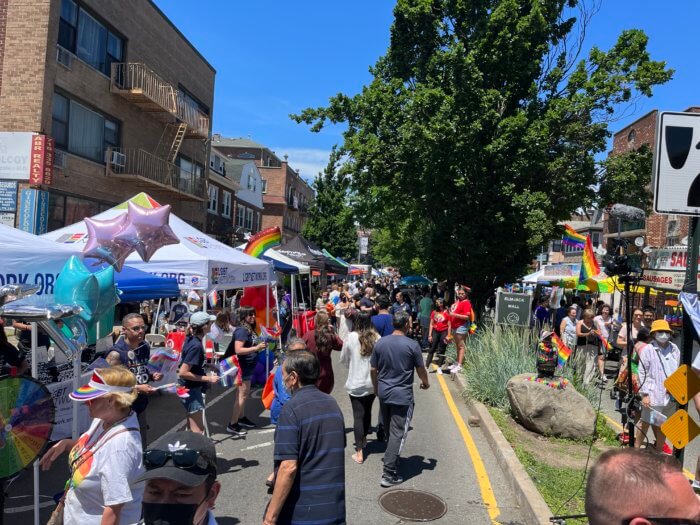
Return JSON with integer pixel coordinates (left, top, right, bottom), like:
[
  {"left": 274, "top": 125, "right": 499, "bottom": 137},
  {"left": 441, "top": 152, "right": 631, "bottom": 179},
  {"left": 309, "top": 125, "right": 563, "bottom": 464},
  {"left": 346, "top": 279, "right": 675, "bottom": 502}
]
[{"left": 455, "top": 374, "right": 553, "bottom": 525}]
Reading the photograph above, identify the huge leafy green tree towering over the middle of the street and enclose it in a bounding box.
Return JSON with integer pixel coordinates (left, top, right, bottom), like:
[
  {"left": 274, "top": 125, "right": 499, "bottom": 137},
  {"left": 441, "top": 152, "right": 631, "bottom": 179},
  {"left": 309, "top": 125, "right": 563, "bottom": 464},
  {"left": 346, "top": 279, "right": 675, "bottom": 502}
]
[{"left": 292, "top": 0, "right": 672, "bottom": 308}]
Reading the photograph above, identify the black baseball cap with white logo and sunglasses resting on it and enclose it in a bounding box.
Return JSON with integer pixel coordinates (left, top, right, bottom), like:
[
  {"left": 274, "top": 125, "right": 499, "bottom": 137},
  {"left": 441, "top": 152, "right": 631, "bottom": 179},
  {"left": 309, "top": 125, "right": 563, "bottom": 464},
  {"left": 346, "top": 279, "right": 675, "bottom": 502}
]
[{"left": 134, "top": 431, "right": 217, "bottom": 487}]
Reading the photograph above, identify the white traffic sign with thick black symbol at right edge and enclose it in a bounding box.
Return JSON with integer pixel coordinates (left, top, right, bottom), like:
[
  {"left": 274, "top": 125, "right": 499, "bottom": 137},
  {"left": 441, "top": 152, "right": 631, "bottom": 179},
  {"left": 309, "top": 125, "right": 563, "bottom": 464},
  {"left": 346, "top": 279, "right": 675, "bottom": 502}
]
[{"left": 652, "top": 112, "right": 700, "bottom": 215}]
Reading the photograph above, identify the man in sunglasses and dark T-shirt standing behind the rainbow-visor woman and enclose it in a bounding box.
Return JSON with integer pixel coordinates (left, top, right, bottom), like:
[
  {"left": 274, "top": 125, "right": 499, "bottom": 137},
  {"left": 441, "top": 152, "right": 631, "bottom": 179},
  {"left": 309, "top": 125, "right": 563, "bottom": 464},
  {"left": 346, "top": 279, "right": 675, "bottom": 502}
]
[{"left": 107, "top": 314, "right": 163, "bottom": 447}]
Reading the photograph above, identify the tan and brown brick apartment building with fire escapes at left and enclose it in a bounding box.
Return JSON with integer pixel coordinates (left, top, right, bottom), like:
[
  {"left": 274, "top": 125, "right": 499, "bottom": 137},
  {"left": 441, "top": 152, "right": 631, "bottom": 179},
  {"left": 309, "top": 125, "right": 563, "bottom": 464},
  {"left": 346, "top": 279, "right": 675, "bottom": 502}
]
[{"left": 0, "top": 0, "right": 216, "bottom": 230}]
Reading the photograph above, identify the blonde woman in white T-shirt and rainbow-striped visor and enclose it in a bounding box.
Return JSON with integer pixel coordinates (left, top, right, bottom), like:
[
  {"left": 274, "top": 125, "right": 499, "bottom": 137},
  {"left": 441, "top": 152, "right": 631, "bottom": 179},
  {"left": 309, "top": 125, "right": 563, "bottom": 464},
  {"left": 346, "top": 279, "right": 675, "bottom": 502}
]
[{"left": 39, "top": 366, "right": 143, "bottom": 525}]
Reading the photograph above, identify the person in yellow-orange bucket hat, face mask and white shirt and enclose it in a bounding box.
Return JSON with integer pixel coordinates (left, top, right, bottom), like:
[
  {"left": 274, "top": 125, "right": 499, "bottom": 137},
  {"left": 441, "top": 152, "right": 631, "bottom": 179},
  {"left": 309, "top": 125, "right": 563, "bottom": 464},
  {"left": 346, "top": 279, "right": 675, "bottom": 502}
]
[{"left": 635, "top": 319, "right": 681, "bottom": 452}]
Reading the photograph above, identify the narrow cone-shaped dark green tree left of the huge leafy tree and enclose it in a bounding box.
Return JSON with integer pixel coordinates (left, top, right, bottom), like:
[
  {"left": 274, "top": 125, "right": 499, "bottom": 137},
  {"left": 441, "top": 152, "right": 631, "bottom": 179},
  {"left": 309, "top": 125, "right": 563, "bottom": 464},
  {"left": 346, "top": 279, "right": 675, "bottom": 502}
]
[{"left": 301, "top": 147, "right": 357, "bottom": 261}]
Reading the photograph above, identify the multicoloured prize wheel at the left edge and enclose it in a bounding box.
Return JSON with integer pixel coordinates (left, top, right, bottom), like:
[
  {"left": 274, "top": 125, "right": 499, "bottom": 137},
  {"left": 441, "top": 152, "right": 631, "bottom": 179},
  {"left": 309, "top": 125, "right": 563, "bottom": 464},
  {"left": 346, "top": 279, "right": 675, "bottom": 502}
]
[{"left": 0, "top": 377, "right": 55, "bottom": 479}]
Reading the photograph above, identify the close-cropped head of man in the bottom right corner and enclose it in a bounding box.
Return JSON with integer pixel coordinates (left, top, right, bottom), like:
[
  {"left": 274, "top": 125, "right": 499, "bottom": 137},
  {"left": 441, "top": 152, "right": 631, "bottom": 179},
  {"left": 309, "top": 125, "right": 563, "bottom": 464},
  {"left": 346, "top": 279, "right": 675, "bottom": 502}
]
[{"left": 585, "top": 448, "right": 700, "bottom": 525}]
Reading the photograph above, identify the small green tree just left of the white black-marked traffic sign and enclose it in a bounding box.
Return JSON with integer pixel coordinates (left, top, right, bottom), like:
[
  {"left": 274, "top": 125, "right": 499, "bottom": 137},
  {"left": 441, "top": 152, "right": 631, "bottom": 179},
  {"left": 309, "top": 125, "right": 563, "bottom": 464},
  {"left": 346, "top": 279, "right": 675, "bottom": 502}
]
[{"left": 598, "top": 144, "right": 654, "bottom": 212}]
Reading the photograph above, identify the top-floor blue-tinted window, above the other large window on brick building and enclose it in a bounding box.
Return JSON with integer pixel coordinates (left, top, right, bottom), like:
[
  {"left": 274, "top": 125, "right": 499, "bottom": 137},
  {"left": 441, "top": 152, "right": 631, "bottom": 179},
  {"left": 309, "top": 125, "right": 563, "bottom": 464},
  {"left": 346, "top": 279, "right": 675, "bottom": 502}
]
[{"left": 58, "top": 0, "right": 124, "bottom": 75}]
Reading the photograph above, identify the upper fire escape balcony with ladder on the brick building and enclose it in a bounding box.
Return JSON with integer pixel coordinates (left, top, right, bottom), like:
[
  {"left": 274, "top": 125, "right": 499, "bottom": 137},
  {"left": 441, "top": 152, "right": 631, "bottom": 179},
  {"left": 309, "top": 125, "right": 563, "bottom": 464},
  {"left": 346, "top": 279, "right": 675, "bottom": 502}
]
[{"left": 111, "top": 62, "right": 209, "bottom": 138}]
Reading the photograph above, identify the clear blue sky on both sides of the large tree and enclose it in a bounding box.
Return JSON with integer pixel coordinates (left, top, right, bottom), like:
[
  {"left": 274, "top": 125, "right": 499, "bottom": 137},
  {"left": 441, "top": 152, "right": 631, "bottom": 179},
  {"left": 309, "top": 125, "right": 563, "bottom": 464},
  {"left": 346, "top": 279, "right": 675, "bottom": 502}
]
[{"left": 156, "top": 0, "right": 700, "bottom": 179}]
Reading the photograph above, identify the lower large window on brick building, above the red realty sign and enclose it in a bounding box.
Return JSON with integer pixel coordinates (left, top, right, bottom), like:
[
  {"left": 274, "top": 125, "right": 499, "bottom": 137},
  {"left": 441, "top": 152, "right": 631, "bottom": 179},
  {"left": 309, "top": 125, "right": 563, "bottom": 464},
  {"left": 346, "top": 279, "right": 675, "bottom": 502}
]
[{"left": 51, "top": 93, "right": 120, "bottom": 162}]
